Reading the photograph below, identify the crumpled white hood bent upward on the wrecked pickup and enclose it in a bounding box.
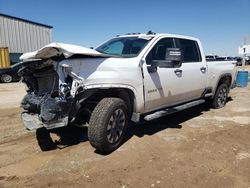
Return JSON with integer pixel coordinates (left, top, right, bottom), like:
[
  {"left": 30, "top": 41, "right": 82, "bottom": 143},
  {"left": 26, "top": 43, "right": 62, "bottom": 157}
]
[{"left": 20, "top": 42, "right": 107, "bottom": 61}]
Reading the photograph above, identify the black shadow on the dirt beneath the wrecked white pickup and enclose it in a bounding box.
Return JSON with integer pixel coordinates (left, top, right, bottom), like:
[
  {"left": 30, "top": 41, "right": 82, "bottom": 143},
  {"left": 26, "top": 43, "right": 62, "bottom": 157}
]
[{"left": 36, "top": 99, "right": 223, "bottom": 155}]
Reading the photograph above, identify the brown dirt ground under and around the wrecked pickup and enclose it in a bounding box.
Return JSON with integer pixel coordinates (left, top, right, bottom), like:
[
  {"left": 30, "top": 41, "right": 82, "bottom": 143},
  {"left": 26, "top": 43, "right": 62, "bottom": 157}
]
[{"left": 0, "top": 68, "right": 250, "bottom": 188}]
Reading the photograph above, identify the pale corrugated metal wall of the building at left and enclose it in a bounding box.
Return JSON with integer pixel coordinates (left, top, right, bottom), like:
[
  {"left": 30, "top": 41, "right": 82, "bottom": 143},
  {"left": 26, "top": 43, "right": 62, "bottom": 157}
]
[{"left": 0, "top": 15, "right": 52, "bottom": 53}]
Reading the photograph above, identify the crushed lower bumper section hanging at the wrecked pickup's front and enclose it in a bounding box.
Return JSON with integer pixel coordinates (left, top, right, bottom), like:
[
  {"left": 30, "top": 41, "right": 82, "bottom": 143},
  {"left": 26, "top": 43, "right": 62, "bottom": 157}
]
[{"left": 21, "top": 94, "right": 72, "bottom": 130}]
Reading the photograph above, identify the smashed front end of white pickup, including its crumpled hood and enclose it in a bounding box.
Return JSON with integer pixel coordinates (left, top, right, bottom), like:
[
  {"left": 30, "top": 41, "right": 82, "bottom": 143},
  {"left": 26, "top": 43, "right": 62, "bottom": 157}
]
[{"left": 19, "top": 43, "right": 110, "bottom": 129}]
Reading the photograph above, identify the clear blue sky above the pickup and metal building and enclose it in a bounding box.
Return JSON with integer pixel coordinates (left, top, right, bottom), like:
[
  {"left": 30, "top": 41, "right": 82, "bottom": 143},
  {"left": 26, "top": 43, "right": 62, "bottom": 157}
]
[{"left": 0, "top": 0, "right": 250, "bottom": 55}]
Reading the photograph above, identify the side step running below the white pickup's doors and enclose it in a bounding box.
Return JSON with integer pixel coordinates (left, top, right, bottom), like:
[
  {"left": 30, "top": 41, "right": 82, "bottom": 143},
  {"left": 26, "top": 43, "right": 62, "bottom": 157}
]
[{"left": 144, "top": 99, "right": 205, "bottom": 121}]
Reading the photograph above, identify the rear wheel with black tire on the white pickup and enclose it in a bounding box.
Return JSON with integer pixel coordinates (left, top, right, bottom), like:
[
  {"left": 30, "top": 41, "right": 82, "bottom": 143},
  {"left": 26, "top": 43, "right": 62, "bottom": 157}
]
[{"left": 212, "top": 84, "right": 228, "bottom": 108}]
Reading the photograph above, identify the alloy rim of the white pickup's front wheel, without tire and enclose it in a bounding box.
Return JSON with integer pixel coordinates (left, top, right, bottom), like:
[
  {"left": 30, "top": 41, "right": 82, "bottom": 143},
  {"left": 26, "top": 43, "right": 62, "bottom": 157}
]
[{"left": 107, "top": 108, "right": 125, "bottom": 144}]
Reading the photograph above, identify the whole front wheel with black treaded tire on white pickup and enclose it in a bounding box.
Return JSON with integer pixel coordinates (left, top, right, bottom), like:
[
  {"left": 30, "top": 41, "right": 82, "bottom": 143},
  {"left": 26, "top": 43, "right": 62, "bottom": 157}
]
[{"left": 88, "top": 98, "right": 128, "bottom": 153}]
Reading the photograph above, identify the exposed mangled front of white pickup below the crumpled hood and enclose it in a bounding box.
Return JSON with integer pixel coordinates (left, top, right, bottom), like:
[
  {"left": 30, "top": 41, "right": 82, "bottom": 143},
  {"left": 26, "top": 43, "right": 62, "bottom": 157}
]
[{"left": 19, "top": 59, "right": 77, "bottom": 130}]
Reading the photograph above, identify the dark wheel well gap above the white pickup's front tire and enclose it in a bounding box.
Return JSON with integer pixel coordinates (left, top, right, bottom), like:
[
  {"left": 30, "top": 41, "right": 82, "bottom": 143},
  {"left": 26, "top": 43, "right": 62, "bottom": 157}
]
[{"left": 79, "top": 88, "right": 135, "bottom": 117}]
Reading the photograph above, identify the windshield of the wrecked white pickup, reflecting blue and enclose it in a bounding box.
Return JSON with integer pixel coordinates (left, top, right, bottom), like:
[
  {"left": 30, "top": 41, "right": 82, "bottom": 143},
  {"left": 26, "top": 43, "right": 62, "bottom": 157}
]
[{"left": 95, "top": 37, "right": 151, "bottom": 57}]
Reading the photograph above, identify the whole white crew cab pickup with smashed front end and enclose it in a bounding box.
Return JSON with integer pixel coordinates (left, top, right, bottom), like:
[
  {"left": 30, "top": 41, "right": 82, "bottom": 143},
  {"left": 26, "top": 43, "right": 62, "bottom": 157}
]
[{"left": 19, "top": 33, "right": 236, "bottom": 153}]
